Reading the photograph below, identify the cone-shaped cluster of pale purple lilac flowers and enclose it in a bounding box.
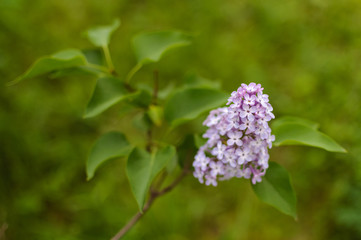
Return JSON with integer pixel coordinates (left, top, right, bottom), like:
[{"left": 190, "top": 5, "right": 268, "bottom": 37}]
[{"left": 193, "top": 83, "right": 275, "bottom": 186}]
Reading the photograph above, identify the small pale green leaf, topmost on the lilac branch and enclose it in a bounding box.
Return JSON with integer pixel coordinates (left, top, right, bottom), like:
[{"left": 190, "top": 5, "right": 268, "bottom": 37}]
[{"left": 85, "top": 19, "right": 120, "bottom": 47}]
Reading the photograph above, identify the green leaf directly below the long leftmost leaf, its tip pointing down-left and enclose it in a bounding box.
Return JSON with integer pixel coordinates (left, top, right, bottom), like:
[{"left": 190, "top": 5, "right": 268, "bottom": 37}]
[{"left": 84, "top": 77, "right": 133, "bottom": 118}]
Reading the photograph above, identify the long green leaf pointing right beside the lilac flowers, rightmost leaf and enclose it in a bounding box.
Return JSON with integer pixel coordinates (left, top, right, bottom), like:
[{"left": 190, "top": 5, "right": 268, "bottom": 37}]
[{"left": 272, "top": 122, "right": 346, "bottom": 153}]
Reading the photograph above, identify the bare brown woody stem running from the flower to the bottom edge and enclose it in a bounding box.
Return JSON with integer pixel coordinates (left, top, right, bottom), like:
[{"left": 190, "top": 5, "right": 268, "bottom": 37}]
[{"left": 111, "top": 168, "right": 189, "bottom": 240}]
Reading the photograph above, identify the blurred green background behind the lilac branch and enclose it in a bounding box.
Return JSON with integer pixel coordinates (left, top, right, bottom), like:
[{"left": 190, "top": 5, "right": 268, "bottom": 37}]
[{"left": 0, "top": 0, "right": 361, "bottom": 240}]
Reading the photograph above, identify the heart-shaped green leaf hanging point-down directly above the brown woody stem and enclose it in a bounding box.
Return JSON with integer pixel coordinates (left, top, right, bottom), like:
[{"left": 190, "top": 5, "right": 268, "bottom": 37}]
[{"left": 126, "top": 146, "right": 175, "bottom": 212}]
